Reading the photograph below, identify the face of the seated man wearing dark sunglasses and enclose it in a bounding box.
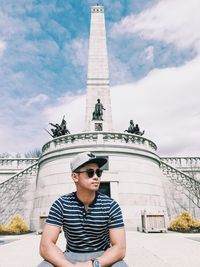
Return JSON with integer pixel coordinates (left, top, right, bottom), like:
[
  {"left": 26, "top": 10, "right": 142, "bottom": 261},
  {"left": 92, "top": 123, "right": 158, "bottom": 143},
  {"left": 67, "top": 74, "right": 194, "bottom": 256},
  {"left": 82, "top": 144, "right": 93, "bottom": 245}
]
[{"left": 72, "top": 163, "right": 101, "bottom": 191}]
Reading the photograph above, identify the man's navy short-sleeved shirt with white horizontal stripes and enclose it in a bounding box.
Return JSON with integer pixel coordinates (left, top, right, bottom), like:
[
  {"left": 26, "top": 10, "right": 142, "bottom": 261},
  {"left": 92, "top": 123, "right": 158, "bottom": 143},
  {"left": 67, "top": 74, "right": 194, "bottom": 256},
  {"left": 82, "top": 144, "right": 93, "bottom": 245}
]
[{"left": 47, "top": 192, "right": 124, "bottom": 253}]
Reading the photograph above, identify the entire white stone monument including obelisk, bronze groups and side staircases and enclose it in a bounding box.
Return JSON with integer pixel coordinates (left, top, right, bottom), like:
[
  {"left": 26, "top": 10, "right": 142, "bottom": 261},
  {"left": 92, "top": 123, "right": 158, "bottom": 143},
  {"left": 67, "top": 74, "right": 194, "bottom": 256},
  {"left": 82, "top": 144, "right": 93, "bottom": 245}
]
[{"left": 0, "top": 5, "right": 200, "bottom": 232}]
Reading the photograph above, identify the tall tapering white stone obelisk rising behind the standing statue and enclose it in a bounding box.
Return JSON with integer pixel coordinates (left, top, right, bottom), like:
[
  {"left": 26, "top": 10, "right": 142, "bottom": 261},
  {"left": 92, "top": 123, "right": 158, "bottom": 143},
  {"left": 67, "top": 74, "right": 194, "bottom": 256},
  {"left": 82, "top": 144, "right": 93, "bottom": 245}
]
[{"left": 85, "top": 5, "right": 113, "bottom": 131}]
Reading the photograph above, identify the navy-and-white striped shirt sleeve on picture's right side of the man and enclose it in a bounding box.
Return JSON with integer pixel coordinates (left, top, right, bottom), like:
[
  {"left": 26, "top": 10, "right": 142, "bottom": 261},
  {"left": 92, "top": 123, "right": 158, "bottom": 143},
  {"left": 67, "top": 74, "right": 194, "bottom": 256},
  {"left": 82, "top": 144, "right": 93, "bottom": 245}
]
[{"left": 108, "top": 200, "right": 124, "bottom": 229}]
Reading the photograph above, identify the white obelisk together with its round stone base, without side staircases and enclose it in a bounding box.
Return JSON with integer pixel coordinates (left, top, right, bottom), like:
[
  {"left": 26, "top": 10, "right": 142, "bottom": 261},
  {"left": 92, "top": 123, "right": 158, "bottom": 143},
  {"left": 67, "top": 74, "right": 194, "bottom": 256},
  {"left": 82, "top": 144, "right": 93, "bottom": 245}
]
[{"left": 31, "top": 5, "right": 167, "bottom": 230}]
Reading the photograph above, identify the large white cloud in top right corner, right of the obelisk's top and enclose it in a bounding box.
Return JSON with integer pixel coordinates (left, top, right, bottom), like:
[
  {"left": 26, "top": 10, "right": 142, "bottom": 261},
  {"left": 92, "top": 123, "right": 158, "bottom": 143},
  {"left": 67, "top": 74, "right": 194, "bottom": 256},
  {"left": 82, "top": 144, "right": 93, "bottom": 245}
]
[{"left": 112, "top": 0, "right": 200, "bottom": 50}]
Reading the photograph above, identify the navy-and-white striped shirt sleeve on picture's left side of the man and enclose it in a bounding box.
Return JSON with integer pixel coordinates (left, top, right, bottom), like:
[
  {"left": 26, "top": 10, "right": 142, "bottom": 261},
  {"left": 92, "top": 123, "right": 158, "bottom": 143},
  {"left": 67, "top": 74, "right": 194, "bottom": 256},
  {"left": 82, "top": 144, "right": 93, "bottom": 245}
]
[{"left": 46, "top": 198, "right": 63, "bottom": 227}]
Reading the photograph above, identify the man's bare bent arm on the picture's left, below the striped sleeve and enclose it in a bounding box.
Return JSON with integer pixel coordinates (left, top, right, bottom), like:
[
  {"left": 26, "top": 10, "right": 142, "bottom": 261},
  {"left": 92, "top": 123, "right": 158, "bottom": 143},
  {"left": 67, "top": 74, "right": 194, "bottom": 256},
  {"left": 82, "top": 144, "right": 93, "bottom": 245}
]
[{"left": 40, "top": 224, "right": 74, "bottom": 267}]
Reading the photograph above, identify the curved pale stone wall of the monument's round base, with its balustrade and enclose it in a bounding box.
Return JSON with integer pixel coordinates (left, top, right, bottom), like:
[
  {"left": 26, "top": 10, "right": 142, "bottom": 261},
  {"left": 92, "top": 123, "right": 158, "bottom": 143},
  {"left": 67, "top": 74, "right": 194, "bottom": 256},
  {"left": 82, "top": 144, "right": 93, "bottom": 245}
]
[{"left": 32, "top": 132, "right": 166, "bottom": 229}]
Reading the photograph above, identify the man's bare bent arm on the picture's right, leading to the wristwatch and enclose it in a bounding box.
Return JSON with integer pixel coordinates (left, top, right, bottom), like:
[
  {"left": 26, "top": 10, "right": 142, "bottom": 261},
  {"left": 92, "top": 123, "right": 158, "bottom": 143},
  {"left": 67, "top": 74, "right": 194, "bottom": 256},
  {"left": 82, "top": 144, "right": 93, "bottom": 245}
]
[{"left": 95, "top": 228, "right": 126, "bottom": 267}]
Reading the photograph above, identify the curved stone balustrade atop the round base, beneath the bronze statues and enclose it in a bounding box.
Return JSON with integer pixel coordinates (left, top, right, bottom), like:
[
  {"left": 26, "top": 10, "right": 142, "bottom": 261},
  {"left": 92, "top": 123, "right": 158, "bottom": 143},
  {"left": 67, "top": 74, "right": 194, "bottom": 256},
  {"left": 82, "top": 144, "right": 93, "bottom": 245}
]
[{"left": 42, "top": 132, "right": 157, "bottom": 154}]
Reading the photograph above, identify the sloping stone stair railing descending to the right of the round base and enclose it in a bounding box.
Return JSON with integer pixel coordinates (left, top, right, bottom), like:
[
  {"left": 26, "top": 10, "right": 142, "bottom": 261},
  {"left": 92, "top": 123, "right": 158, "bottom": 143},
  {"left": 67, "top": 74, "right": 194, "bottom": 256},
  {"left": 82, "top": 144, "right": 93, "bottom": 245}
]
[{"left": 160, "top": 160, "right": 200, "bottom": 208}]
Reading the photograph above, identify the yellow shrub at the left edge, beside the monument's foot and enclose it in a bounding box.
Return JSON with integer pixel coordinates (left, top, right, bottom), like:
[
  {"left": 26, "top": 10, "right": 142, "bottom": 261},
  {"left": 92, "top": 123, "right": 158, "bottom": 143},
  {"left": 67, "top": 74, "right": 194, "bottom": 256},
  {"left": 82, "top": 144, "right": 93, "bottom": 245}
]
[{"left": 0, "top": 214, "right": 29, "bottom": 234}]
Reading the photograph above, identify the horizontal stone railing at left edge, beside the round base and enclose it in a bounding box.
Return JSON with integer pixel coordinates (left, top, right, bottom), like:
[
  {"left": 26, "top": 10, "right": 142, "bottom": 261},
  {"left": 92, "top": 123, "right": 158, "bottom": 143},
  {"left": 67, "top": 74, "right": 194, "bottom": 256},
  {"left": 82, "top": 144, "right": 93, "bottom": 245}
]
[{"left": 0, "top": 158, "right": 38, "bottom": 170}]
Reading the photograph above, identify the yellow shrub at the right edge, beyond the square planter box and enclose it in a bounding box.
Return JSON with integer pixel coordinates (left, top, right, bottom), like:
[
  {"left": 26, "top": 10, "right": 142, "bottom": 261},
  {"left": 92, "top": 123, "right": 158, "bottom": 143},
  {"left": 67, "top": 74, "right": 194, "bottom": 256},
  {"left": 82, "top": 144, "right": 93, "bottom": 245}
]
[{"left": 168, "top": 211, "right": 200, "bottom": 233}]
